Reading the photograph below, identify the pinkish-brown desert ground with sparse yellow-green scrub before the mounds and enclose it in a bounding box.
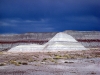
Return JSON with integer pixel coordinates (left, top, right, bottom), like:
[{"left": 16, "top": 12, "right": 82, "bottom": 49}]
[{"left": 0, "top": 49, "right": 100, "bottom": 75}]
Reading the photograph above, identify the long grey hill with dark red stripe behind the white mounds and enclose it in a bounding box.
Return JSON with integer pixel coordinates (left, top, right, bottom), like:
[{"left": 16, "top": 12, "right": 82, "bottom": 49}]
[{"left": 0, "top": 30, "right": 100, "bottom": 51}]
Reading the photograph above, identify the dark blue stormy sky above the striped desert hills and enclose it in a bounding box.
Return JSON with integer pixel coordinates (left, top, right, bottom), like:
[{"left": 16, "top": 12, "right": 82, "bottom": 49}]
[{"left": 0, "top": 0, "right": 100, "bottom": 33}]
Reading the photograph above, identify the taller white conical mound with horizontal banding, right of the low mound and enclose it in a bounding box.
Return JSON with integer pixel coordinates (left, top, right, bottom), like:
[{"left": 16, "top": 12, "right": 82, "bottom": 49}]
[{"left": 44, "top": 32, "right": 86, "bottom": 51}]
